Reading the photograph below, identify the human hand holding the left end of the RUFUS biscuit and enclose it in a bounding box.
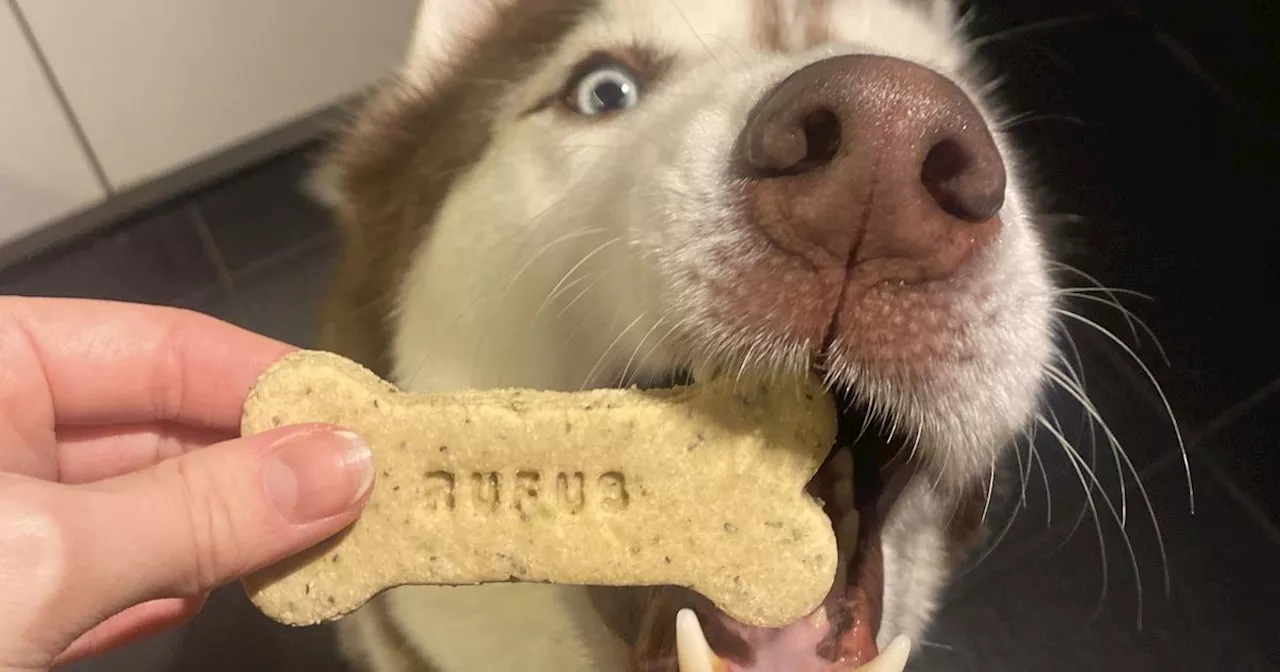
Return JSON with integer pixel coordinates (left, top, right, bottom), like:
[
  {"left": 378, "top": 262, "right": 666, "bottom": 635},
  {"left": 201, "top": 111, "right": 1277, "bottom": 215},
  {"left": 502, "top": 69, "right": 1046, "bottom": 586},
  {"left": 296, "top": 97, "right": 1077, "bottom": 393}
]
[{"left": 0, "top": 297, "right": 374, "bottom": 672}]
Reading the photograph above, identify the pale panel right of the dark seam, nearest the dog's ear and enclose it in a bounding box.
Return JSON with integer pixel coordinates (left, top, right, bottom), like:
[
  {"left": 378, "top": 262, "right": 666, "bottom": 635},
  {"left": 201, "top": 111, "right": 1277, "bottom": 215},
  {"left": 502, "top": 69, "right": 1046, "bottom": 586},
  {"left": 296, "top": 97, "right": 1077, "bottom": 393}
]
[{"left": 18, "top": 0, "right": 417, "bottom": 188}]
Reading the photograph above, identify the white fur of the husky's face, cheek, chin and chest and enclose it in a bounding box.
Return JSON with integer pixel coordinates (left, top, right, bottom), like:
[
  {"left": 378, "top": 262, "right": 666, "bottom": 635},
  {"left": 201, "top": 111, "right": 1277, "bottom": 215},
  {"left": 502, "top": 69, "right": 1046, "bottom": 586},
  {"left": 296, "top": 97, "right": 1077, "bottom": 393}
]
[{"left": 342, "top": 0, "right": 1053, "bottom": 672}]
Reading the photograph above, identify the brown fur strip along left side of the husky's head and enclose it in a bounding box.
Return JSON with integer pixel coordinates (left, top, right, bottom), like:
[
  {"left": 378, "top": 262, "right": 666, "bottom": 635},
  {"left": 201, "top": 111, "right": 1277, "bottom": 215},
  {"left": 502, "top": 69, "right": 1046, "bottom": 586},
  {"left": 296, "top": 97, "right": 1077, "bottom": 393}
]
[{"left": 319, "top": 0, "right": 595, "bottom": 376}]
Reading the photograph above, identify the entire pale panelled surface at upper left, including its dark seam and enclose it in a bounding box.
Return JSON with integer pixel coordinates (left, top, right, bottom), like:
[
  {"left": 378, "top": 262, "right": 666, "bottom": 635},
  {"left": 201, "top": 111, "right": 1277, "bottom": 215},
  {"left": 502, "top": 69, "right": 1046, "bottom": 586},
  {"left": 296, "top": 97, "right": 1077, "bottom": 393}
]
[{"left": 0, "top": 0, "right": 417, "bottom": 246}]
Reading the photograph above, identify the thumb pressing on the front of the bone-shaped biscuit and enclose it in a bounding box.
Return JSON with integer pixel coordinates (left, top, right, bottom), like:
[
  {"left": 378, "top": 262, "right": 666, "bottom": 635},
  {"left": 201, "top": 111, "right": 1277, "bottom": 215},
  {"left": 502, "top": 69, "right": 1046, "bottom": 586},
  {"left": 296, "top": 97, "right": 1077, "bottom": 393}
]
[{"left": 51, "top": 426, "right": 374, "bottom": 644}]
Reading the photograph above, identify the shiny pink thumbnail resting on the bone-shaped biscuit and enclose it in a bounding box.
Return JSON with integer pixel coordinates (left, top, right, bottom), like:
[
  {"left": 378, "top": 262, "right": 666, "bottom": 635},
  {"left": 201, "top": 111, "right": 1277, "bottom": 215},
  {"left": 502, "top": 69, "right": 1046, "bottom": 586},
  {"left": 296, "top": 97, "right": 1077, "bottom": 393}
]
[{"left": 262, "top": 431, "right": 374, "bottom": 524}]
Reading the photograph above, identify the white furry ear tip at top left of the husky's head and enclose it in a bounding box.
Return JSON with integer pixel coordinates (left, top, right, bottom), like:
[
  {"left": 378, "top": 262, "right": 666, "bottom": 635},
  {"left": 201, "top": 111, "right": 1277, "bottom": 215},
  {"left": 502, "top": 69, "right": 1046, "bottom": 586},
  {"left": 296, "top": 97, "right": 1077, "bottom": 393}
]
[{"left": 404, "top": 0, "right": 520, "bottom": 86}]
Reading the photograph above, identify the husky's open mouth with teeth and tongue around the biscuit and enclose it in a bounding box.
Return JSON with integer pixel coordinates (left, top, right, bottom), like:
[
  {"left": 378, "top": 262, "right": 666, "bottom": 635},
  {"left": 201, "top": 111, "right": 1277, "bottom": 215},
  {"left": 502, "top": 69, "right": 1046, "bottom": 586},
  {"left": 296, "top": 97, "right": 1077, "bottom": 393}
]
[{"left": 634, "top": 373, "right": 913, "bottom": 672}]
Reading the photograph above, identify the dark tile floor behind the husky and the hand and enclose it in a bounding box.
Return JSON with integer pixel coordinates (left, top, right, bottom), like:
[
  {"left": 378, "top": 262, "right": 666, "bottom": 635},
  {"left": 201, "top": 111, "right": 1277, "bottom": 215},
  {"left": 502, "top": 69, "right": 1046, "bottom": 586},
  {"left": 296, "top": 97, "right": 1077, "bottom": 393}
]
[{"left": 0, "top": 3, "right": 1280, "bottom": 672}]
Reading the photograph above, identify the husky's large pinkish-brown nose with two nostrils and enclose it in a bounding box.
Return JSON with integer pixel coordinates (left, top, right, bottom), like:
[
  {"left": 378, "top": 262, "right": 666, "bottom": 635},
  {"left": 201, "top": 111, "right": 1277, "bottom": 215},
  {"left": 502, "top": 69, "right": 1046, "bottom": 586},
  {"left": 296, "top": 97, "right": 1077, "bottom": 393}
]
[{"left": 740, "top": 55, "right": 1006, "bottom": 282}]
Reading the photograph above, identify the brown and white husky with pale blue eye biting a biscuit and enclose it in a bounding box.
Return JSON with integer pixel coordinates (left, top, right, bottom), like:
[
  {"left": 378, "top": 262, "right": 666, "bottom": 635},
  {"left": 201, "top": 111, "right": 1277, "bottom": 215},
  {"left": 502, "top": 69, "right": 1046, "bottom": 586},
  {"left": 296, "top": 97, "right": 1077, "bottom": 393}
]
[{"left": 314, "top": 0, "right": 1056, "bottom": 672}]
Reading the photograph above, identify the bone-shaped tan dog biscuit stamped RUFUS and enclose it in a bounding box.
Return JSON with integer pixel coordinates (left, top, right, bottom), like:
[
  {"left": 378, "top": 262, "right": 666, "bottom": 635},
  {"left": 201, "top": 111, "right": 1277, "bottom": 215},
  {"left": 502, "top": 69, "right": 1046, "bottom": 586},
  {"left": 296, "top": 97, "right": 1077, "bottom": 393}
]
[{"left": 243, "top": 352, "right": 836, "bottom": 627}]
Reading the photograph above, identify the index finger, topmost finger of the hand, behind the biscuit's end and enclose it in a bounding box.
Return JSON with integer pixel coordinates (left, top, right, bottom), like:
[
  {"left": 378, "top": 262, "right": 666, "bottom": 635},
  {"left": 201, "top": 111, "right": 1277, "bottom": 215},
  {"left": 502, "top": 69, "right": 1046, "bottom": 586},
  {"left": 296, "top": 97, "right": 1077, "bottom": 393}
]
[{"left": 0, "top": 297, "right": 294, "bottom": 430}]
